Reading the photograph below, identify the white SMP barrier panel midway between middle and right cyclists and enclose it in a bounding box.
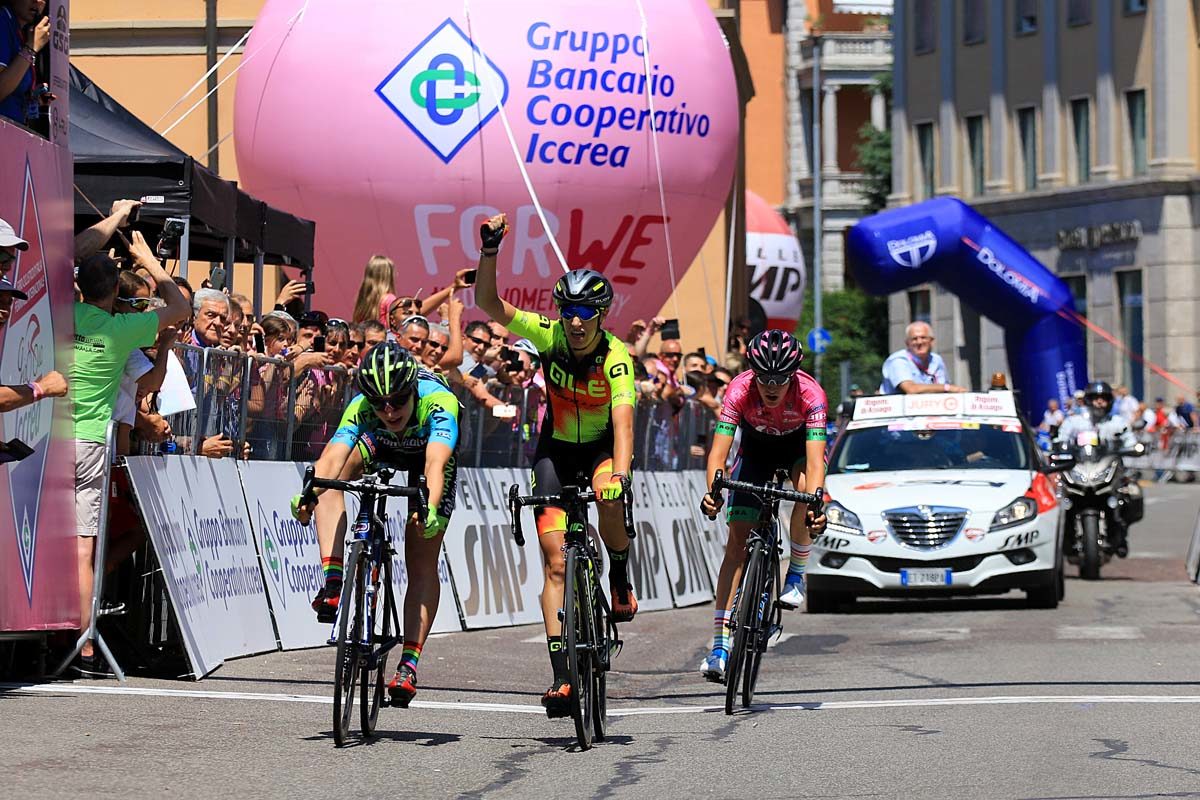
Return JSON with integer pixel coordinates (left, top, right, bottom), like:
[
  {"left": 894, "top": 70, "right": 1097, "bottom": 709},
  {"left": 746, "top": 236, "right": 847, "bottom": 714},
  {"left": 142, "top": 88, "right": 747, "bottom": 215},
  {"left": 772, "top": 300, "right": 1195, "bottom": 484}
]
[{"left": 647, "top": 473, "right": 713, "bottom": 607}]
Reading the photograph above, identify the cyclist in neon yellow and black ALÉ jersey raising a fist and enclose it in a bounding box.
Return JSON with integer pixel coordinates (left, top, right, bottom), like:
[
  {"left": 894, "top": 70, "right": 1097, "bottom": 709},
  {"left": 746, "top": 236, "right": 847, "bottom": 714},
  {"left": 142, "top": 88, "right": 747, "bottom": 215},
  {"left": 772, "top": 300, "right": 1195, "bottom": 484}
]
[{"left": 475, "top": 215, "right": 637, "bottom": 717}]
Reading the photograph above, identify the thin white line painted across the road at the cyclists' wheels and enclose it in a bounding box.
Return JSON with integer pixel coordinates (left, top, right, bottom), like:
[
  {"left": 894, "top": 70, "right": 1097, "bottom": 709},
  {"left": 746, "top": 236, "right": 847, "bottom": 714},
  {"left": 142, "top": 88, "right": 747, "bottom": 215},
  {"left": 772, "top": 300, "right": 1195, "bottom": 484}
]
[{"left": 7, "top": 684, "right": 1200, "bottom": 717}]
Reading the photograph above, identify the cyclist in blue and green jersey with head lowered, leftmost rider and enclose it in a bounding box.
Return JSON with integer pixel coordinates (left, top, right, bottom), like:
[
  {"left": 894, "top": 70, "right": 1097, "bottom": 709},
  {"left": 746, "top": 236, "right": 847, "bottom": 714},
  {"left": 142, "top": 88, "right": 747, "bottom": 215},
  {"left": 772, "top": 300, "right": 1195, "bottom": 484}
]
[{"left": 292, "top": 342, "right": 458, "bottom": 708}]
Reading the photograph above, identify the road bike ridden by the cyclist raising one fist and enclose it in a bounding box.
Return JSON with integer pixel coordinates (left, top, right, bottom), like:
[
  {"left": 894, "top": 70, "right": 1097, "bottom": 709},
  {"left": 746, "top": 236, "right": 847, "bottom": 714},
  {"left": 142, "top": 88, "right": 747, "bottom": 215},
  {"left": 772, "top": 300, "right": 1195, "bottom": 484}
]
[{"left": 509, "top": 476, "right": 635, "bottom": 750}]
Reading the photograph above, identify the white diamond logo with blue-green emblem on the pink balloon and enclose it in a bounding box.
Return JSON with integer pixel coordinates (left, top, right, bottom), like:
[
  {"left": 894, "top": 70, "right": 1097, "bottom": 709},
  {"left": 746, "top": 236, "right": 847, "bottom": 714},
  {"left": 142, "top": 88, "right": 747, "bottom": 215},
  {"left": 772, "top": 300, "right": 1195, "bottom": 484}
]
[{"left": 376, "top": 18, "right": 509, "bottom": 164}]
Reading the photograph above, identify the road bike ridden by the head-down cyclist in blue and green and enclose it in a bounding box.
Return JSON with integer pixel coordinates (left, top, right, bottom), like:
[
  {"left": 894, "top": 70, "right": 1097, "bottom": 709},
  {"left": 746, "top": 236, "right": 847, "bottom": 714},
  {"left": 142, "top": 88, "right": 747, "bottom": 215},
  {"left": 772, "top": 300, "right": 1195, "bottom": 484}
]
[{"left": 304, "top": 467, "right": 428, "bottom": 747}]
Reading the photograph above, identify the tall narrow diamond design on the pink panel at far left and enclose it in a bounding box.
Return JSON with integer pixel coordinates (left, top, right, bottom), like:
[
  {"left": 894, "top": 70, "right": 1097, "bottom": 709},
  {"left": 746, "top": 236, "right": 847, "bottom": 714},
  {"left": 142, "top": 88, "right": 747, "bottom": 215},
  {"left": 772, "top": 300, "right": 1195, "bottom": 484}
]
[{"left": 0, "top": 161, "right": 54, "bottom": 603}]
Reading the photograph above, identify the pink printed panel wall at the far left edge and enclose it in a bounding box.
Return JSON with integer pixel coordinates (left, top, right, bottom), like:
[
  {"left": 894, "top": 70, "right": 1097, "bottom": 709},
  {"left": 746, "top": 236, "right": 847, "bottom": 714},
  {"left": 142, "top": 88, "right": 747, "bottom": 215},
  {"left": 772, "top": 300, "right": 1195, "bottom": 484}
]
[{"left": 0, "top": 123, "right": 79, "bottom": 631}]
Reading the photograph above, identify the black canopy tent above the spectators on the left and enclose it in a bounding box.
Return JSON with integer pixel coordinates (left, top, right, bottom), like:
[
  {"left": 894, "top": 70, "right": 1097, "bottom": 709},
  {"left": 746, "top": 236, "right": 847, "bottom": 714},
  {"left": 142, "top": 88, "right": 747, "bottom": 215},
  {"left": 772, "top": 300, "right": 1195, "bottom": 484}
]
[{"left": 70, "top": 66, "right": 316, "bottom": 302}]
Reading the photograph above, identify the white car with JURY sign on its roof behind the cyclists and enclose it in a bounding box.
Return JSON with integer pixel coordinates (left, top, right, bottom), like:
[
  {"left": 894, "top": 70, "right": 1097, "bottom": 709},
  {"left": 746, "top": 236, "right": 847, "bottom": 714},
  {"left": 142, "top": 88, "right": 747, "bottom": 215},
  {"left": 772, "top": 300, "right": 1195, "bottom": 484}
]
[{"left": 806, "top": 392, "right": 1069, "bottom": 613}]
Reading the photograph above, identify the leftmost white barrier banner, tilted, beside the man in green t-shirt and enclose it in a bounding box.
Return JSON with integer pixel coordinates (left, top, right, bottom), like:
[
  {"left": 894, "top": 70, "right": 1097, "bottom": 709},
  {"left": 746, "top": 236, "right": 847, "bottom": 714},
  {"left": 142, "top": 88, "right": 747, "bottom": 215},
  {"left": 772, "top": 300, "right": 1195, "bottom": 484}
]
[{"left": 126, "top": 456, "right": 277, "bottom": 678}]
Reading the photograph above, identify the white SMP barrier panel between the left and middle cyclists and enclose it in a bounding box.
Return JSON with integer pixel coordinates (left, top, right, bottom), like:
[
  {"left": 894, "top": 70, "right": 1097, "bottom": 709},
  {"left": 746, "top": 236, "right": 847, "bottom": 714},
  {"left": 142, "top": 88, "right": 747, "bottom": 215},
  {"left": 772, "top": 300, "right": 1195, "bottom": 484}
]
[{"left": 445, "top": 469, "right": 542, "bottom": 628}]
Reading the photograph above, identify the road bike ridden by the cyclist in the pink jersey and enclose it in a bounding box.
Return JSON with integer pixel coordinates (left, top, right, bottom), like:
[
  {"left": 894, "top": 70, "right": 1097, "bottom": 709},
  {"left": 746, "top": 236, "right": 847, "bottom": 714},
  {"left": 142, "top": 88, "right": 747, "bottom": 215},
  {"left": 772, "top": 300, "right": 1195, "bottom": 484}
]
[{"left": 709, "top": 469, "right": 824, "bottom": 714}]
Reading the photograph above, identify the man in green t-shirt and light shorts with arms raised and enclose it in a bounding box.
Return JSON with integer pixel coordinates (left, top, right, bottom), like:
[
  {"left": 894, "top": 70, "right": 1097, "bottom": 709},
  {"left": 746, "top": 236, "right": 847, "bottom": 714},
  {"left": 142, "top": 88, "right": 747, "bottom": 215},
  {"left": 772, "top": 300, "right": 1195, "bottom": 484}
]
[{"left": 68, "top": 230, "right": 190, "bottom": 673}]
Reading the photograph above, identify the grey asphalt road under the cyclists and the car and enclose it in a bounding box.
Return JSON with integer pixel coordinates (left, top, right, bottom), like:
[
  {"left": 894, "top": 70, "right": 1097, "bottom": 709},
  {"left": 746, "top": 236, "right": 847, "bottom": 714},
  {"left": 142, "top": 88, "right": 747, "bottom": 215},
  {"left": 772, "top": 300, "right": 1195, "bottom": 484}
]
[{"left": 0, "top": 486, "right": 1200, "bottom": 799}]
